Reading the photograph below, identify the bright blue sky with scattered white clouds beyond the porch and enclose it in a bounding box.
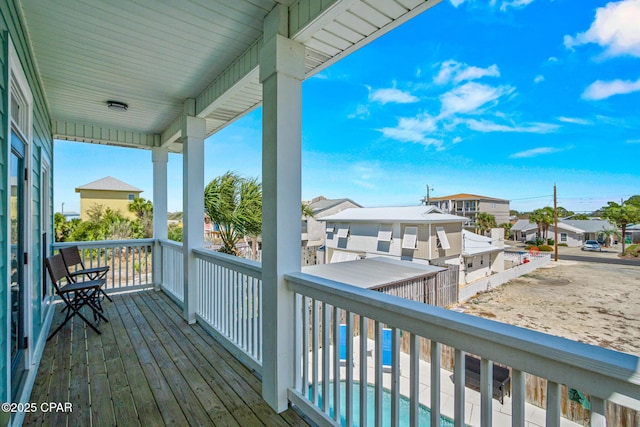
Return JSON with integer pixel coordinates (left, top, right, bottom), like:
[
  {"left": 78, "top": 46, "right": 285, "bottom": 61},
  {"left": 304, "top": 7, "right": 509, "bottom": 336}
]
[{"left": 54, "top": 0, "right": 640, "bottom": 212}]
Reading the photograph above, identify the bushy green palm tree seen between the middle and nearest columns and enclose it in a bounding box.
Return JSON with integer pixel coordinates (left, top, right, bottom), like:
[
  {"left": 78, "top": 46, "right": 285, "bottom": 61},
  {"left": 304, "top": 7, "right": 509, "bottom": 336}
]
[{"left": 204, "top": 171, "right": 262, "bottom": 255}]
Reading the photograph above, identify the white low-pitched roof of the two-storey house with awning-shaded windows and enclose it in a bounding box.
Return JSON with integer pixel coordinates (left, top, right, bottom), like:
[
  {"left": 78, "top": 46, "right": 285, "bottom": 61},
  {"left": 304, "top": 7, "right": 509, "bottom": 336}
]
[{"left": 321, "top": 206, "right": 468, "bottom": 224}]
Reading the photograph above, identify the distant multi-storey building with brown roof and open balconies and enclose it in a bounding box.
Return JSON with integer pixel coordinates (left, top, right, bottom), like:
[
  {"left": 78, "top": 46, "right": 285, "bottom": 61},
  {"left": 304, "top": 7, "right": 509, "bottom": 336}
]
[{"left": 424, "top": 193, "right": 509, "bottom": 228}]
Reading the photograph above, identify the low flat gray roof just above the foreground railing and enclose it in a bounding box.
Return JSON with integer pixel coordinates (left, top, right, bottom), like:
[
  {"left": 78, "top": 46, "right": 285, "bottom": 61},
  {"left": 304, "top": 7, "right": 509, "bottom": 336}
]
[{"left": 302, "top": 257, "right": 446, "bottom": 289}]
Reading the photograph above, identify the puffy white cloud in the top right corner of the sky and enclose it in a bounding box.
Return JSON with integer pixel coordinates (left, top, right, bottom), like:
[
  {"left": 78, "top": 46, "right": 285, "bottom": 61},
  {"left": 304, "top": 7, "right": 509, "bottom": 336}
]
[{"left": 564, "top": 0, "right": 640, "bottom": 56}]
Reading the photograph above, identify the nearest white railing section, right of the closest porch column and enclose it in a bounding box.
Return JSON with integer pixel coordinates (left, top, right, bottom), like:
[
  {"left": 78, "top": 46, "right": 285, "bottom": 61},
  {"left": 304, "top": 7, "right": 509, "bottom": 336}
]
[{"left": 286, "top": 273, "right": 640, "bottom": 426}]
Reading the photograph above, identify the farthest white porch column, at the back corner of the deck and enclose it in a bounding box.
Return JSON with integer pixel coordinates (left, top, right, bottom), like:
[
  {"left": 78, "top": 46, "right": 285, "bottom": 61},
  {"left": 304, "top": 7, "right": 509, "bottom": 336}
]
[{"left": 151, "top": 147, "right": 169, "bottom": 290}]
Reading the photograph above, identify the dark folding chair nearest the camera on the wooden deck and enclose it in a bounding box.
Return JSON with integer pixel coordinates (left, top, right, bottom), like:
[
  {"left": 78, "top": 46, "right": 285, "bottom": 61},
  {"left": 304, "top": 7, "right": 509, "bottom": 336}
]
[{"left": 45, "top": 254, "right": 109, "bottom": 341}]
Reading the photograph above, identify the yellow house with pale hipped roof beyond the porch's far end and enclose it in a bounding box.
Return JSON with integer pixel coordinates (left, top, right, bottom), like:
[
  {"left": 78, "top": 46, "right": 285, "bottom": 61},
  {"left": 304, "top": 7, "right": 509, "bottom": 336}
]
[{"left": 76, "top": 176, "right": 142, "bottom": 221}]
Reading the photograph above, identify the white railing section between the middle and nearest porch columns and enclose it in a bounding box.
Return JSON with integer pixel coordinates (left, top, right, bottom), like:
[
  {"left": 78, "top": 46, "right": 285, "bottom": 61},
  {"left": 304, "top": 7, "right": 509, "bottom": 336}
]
[{"left": 194, "top": 250, "right": 262, "bottom": 373}]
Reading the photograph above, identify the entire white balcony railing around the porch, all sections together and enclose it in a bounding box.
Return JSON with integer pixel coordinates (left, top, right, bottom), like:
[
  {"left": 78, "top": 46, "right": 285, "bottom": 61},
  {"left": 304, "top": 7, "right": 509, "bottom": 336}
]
[{"left": 54, "top": 240, "right": 640, "bottom": 426}]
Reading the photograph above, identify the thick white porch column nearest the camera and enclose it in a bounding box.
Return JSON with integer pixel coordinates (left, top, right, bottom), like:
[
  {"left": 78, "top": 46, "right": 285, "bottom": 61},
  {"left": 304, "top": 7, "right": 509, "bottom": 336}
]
[{"left": 260, "top": 5, "right": 305, "bottom": 412}]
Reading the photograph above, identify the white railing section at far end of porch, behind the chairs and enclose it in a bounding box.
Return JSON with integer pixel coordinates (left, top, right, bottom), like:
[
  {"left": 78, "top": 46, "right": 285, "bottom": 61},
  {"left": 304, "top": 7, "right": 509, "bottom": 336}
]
[{"left": 53, "top": 239, "right": 154, "bottom": 292}]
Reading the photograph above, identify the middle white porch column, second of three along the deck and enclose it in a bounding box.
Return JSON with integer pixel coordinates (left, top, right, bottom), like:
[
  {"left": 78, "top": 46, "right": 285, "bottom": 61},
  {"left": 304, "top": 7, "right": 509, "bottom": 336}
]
[{"left": 182, "top": 99, "right": 206, "bottom": 323}]
